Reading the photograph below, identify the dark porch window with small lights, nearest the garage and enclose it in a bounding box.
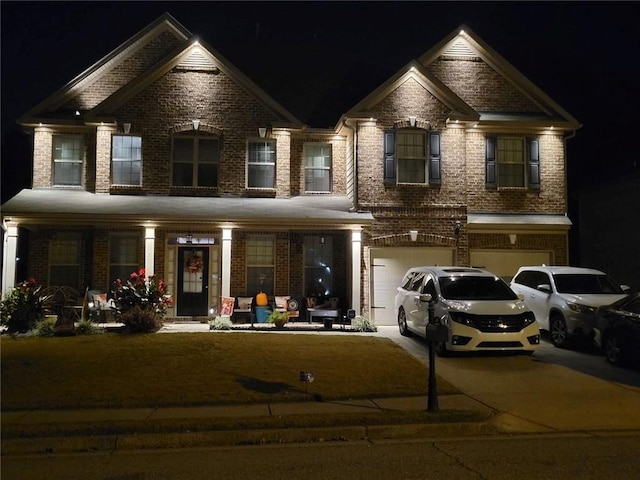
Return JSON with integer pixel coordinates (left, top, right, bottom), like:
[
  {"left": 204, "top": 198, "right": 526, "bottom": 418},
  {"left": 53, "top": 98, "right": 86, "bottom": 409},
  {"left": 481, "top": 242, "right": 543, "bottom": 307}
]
[{"left": 303, "top": 235, "right": 333, "bottom": 297}]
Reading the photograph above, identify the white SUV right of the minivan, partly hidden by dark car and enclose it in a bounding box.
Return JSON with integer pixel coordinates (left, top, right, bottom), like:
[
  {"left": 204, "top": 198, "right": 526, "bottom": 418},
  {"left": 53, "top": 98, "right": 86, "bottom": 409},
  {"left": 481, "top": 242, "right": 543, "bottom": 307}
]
[{"left": 511, "top": 265, "right": 629, "bottom": 347}]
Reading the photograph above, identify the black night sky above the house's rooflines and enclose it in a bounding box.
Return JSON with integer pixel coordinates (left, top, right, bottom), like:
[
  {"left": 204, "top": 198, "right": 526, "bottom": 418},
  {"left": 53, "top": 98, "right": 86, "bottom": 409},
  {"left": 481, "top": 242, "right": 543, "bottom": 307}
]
[{"left": 0, "top": 1, "right": 640, "bottom": 208}]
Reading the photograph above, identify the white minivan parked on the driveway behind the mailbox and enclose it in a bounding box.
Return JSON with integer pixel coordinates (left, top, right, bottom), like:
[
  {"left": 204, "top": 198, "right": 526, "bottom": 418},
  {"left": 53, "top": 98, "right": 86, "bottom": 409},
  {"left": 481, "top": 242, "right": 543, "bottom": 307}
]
[{"left": 395, "top": 267, "right": 540, "bottom": 355}]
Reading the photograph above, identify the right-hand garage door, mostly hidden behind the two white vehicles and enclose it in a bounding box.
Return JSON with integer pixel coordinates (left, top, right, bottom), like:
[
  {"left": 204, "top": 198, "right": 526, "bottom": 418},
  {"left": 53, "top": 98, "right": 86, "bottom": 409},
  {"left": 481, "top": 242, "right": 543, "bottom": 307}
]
[{"left": 469, "top": 250, "right": 553, "bottom": 281}]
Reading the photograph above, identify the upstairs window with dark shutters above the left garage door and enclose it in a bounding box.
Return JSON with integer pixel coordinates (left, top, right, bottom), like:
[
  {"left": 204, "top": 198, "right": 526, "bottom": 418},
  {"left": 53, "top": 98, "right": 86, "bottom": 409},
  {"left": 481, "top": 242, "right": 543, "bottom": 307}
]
[{"left": 383, "top": 130, "right": 442, "bottom": 185}]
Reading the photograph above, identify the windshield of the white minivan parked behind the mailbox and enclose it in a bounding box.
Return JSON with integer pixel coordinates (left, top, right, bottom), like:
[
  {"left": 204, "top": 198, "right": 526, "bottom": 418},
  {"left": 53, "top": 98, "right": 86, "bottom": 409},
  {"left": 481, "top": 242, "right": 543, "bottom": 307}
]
[{"left": 438, "top": 276, "right": 518, "bottom": 300}]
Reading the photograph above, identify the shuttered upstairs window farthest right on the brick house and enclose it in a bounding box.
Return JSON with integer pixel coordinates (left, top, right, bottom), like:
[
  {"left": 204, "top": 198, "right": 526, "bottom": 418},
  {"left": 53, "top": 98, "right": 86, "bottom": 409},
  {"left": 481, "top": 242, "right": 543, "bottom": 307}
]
[{"left": 485, "top": 136, "right": 540, "bottom": 189}]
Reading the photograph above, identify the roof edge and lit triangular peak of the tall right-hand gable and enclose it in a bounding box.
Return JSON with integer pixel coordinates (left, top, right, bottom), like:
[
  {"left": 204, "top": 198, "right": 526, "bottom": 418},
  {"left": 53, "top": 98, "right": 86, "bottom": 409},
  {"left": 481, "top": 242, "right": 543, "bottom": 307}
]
[{"left": 418, "top": 24, "right": 581, "bottom": 130}]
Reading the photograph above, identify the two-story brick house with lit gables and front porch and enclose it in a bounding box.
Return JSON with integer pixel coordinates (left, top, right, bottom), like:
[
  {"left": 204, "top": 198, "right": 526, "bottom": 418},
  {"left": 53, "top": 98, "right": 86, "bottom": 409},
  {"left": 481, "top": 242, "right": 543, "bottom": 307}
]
[{"left": 2, "top": 15, "right": 580, "bottom": 324}]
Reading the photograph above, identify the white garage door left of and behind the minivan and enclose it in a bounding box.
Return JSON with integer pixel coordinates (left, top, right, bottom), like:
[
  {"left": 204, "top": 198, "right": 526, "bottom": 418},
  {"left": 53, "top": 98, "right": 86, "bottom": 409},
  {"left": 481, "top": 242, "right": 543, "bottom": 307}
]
[{"left": 369, "top": 247, "right": 453, "bottom": 325}]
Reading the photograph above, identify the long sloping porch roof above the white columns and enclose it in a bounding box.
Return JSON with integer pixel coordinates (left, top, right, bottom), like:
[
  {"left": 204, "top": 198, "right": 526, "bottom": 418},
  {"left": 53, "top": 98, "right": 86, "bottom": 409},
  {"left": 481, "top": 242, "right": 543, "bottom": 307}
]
[{"left": 2, "top": 189, "right": 374, "bottom": 229}]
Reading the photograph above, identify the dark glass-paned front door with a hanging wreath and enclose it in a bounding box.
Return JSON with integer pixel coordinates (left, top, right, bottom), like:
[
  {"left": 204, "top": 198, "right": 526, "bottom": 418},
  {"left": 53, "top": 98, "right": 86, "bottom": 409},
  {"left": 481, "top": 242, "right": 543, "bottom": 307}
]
[{"left": 176, "top": 247, "right": 209, "bottom": 317}]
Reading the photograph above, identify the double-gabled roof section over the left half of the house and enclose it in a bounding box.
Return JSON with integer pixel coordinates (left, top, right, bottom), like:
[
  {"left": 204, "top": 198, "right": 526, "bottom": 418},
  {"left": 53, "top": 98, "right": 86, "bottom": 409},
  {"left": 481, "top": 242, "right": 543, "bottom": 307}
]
[{"left": 20, "top": 13, "right": 302, "bottom": 128}]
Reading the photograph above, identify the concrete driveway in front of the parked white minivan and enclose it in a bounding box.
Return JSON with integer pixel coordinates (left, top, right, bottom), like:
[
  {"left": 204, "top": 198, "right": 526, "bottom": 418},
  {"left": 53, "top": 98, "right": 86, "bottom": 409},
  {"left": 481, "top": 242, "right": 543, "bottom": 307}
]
[{"left": 378, "top": 326, "right": 640, "bottom": 432}]
